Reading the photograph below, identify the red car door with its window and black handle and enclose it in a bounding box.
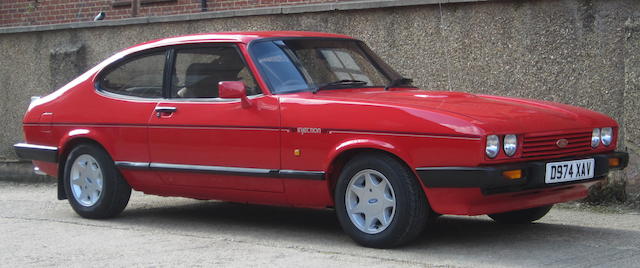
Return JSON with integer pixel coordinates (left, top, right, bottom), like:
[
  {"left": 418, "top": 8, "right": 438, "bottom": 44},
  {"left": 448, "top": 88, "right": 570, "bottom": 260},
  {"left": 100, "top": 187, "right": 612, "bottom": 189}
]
[{"left": 149, "top": 44, "right": 283, "bottom": 192}]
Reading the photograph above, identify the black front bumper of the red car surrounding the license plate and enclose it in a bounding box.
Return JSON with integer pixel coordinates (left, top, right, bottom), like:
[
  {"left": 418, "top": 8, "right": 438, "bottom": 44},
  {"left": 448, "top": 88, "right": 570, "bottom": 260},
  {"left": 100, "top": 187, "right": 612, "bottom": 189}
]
[{"left": 416, "top": 152, "right": 629, "bottom": 195}]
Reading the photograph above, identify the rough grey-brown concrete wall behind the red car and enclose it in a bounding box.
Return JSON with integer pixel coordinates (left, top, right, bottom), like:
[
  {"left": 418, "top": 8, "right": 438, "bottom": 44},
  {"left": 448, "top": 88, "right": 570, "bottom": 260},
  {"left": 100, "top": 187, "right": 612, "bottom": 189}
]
[{"left": 0, "top": 0, "right": 640, "bottom": 197}]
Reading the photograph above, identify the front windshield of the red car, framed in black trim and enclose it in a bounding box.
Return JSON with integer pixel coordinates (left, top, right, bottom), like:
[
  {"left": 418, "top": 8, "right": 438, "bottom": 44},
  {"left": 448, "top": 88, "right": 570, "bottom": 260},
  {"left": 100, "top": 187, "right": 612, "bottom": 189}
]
[{"left": 250, "top": 38, "right": 400, "bottom": 94}]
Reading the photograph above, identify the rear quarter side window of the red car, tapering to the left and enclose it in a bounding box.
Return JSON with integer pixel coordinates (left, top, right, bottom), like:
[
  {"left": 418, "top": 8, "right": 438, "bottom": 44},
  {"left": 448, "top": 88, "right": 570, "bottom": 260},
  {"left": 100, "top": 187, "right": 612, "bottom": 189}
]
[{"left": 99, "top": 51, "right": 165, "bottom": 98}]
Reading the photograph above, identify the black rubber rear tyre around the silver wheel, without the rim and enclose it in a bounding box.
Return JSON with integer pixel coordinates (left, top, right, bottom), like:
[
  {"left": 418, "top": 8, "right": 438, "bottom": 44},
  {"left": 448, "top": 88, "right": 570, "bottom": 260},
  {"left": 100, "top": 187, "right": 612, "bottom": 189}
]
[{"left": 64, "top": 144, "right": 131, "bottom": 219}]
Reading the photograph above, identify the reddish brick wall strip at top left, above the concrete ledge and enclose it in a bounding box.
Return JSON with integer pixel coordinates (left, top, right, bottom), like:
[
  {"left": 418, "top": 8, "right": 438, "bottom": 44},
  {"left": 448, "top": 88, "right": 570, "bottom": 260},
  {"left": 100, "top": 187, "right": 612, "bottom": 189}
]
[{"left": 0, "top": 0, "right": 349, "bottom": 27}]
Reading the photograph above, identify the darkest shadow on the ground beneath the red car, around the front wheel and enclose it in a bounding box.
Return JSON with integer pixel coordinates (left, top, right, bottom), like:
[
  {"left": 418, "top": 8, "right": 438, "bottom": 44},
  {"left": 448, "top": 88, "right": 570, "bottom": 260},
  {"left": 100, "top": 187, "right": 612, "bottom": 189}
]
[{"left": 115, "top": 200, "right": 636, "bottom": 246}]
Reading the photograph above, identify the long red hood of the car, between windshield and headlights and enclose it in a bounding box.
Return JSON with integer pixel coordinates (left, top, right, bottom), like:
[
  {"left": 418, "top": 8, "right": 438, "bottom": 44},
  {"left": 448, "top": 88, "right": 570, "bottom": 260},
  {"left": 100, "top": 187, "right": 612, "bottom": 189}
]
[{"left": 304, "top": 90, "right": 617, "bottom": 134}]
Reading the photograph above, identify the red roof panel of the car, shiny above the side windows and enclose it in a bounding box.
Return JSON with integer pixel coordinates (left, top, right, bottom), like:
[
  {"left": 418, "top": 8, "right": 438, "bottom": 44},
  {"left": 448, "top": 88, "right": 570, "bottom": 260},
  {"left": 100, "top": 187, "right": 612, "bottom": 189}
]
[{"left": 126, "top": 31, "right": 353, "bottom": 51}]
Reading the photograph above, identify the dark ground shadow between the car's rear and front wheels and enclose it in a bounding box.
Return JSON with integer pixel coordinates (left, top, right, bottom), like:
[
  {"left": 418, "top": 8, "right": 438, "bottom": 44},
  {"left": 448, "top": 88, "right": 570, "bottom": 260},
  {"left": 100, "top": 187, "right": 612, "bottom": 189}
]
[{"left": 113, "top": 200, "right": 348, "bottom": 244}]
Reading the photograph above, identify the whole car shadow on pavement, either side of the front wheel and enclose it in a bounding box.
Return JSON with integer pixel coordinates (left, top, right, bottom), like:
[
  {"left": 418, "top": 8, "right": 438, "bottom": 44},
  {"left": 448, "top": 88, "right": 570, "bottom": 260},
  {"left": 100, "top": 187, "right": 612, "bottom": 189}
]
[{"left": 109, "top": 201, "right": 637, "bottom": 254}]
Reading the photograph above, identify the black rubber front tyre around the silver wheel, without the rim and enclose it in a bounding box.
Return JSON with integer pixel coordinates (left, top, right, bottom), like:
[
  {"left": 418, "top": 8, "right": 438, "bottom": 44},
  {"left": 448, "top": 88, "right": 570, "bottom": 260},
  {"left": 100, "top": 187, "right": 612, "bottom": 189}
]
[{"left": 334, "top": 153, "right": 430, "bottom": 248}]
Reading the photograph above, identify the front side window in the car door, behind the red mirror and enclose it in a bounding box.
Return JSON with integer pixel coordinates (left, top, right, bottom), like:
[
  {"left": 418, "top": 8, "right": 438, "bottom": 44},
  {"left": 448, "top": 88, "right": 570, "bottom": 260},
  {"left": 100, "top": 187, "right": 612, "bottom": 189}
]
[{"left": 171, "top": 46, "right": 262, "bottom": 98}]
